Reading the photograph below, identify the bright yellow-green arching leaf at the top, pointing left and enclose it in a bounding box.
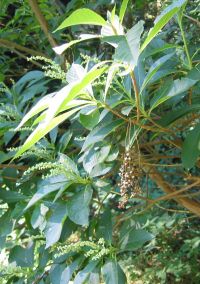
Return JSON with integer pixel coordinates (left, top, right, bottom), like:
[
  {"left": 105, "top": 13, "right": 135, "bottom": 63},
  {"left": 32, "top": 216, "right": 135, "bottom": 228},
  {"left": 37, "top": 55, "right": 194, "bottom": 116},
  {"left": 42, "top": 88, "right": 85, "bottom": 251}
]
[{"left": 55, "top": 8, "right": 106, "bottom": 31}]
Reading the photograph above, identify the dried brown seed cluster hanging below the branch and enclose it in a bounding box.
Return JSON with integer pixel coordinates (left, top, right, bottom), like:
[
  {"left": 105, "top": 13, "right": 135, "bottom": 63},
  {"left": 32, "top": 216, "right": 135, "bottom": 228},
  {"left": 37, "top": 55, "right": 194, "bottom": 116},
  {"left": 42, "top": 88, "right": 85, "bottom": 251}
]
[{"left": 118, "top": 150, "right": 141, "bottom": 208}]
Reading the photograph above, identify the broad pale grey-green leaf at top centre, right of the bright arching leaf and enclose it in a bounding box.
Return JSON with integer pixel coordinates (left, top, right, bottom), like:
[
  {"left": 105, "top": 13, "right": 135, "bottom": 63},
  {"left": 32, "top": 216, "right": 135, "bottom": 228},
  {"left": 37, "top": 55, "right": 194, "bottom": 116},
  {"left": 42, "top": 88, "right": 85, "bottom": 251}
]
[{"left": 114, "top": 21, "right": 144, "bottom": 68}]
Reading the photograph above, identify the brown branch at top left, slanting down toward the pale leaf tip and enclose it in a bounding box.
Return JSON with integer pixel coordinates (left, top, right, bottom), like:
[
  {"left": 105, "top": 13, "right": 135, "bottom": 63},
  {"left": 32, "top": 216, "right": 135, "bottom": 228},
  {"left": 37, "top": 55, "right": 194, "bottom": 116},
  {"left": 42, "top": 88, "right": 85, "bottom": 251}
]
[{"left": 28, "top": 0, "right": 58, "bottom": 47}]
